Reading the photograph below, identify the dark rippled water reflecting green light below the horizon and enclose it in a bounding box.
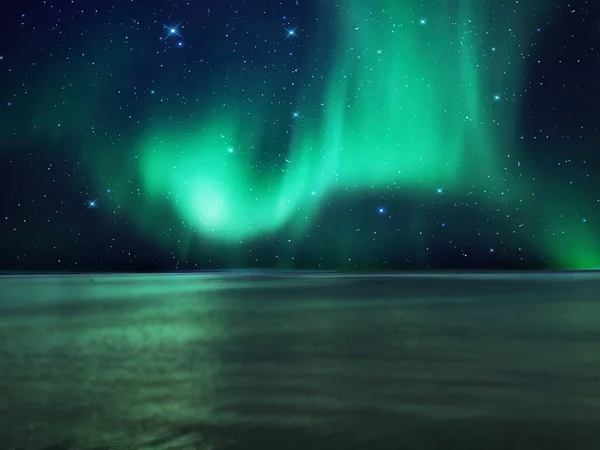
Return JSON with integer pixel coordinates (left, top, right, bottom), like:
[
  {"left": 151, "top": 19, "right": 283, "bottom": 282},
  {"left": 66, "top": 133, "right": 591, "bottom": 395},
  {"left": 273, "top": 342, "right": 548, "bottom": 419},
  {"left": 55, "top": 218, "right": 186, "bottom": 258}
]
[{"left": 0, "top": 273, "right": 600, "bottom": 450}]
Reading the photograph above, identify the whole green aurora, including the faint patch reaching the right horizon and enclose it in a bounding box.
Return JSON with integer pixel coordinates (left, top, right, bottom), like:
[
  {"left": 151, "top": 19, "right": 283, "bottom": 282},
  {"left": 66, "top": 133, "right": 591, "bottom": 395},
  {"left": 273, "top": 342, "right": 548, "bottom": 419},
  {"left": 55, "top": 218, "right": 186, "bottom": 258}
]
[{"left": 5, "top": 0, "right": 600, "bottom": 269}]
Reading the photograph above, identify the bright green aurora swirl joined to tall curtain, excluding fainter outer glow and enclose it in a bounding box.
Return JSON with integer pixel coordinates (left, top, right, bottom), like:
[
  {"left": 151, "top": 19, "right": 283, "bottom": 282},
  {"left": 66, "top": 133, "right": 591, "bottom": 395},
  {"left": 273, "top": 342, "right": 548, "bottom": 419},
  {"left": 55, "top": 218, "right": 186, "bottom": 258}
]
[{"left": 139, "top": 0, "right": 531, "bottom": 237}]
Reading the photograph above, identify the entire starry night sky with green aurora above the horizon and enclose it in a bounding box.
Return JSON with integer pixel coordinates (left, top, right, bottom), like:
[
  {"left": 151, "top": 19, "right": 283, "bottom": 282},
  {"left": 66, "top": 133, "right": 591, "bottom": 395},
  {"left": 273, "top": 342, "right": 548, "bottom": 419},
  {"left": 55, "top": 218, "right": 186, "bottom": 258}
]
[{"left": 0, "top": 0, "right": 600, "bottom": 271}]
